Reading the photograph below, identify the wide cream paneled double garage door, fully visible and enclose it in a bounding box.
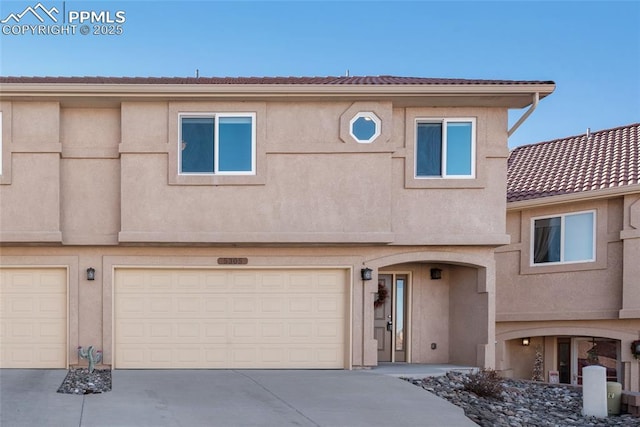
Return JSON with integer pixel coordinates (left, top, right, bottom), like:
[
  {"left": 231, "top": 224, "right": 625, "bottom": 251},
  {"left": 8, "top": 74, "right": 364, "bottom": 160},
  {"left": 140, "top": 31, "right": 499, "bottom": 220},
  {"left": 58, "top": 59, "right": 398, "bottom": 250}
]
[{"left": 114, "top": 269, "right": 348, "bottom": 369}]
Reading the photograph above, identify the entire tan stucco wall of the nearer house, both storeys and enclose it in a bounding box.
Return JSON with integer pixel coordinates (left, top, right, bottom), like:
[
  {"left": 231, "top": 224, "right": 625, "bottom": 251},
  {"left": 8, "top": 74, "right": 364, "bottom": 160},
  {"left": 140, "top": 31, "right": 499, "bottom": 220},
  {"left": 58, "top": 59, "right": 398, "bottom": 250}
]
[{"left": 0, "top": 96, "right": 508, "bottom": 372}]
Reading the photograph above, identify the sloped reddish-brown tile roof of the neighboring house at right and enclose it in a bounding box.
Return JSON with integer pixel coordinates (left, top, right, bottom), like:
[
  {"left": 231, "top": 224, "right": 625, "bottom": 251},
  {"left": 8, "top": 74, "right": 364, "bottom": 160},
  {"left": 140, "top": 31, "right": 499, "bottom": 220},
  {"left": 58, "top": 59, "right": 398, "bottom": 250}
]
[{"left": 507, "top": 123, "right": 640, "bottom": 202}]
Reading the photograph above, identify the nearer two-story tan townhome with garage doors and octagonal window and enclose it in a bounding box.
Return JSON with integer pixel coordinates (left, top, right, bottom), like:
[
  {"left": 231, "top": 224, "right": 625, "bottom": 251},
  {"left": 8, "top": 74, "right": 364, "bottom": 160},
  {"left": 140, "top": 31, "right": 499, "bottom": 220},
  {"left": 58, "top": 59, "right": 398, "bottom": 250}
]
[{"left": 0, "top": 76, "right": 552, "bottom": 369}]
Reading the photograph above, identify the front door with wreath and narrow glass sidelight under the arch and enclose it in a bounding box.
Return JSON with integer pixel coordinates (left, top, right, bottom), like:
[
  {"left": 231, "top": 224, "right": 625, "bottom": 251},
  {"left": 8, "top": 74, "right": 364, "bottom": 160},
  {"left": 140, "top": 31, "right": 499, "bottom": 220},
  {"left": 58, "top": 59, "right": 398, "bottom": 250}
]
[{"left": 374, "top": 274, "right": 408, "bottom": 362}]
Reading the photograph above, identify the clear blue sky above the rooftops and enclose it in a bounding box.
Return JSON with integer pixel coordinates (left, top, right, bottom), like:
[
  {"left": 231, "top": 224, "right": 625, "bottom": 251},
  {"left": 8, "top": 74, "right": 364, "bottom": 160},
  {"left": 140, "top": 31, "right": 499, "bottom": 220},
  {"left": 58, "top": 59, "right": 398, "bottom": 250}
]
[{"left": 0, "top": 0, "right": 640, "bottom": 147}]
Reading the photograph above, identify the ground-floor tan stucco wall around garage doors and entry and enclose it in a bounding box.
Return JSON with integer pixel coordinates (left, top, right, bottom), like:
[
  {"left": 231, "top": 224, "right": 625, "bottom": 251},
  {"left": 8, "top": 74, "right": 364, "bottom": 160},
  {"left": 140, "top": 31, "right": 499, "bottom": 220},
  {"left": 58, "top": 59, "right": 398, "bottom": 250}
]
[{"left": 0, "top": 245, "right": 500, "bottom": 366}]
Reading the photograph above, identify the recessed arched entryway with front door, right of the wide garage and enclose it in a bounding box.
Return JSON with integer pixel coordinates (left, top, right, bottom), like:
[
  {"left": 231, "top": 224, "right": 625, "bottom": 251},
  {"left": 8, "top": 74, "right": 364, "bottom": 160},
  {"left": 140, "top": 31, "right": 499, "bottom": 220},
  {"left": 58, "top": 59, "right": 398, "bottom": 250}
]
[{"left": 365, "top": 252, "right": 495, "bottom": 367}]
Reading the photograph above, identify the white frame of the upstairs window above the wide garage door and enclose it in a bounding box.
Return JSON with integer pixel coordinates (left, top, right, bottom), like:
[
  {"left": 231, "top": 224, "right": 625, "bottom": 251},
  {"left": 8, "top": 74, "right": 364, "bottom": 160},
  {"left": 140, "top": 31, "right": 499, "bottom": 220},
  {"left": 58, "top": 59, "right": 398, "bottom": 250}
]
[{"left": 177, "top": 112, "right": 256, "bottom": 176}]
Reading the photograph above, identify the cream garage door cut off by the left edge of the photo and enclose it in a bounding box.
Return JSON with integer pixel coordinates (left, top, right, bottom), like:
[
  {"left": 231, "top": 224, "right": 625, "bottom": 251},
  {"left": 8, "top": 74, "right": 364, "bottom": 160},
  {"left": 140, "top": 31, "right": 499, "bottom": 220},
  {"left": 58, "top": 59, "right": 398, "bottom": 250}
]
[{"left": 0, "top": 268, "right": 67, "bottom": 368}]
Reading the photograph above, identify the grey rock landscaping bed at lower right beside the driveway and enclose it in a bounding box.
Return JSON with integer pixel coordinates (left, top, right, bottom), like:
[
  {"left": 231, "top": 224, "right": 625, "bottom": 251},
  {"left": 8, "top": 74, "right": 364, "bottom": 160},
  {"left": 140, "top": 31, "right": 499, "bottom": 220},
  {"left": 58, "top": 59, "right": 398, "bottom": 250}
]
[{"left": 405, "top": 372, "right": 640, "bottom": 427}]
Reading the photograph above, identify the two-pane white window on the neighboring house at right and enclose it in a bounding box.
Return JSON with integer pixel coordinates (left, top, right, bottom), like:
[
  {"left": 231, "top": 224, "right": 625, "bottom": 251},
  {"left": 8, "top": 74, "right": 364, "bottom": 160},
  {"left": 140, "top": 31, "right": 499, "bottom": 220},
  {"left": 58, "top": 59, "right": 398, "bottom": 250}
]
[{"left": 531, "top": 211, "right": 596, "bottom": 264}]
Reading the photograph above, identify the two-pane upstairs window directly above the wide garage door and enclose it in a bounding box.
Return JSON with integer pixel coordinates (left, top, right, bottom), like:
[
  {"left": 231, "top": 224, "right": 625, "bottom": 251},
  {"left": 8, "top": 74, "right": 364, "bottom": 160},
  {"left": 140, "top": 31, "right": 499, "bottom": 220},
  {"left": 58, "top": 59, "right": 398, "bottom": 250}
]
[{"left": 178, "top": 113, "right": 256, "bottom": 175}]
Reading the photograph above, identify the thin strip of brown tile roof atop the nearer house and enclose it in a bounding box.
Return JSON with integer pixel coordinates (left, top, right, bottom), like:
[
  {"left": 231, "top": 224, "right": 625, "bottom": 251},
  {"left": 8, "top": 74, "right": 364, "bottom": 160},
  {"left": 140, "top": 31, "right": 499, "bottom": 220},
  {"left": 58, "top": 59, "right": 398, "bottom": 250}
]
[{"left": 0, "top": 76, "right": 554, "bottom": 85}]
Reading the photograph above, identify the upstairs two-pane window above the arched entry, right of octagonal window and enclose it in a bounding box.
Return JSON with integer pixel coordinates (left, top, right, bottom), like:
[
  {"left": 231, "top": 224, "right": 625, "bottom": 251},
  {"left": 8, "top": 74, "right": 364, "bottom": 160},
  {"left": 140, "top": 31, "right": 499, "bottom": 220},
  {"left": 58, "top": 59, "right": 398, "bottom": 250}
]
[{"left": 415, "top": 118, "right": 476, "bottom": 178}]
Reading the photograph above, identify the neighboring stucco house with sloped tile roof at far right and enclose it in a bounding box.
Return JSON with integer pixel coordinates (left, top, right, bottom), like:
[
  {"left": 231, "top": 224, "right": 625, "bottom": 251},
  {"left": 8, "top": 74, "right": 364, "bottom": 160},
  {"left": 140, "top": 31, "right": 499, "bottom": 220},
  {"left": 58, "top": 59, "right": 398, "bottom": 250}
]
[{"left": 496, "top": 123, "right": 640, "bottom": 391}]
